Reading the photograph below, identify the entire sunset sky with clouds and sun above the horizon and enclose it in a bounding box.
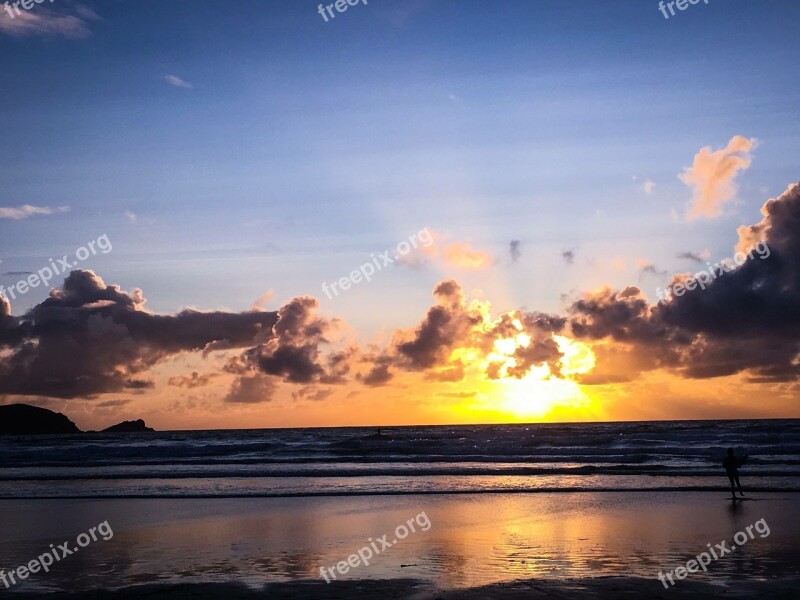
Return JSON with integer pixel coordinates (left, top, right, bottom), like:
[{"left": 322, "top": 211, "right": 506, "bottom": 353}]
[{"left": 0, "top": 0, "right": 800, "bottom": 429}]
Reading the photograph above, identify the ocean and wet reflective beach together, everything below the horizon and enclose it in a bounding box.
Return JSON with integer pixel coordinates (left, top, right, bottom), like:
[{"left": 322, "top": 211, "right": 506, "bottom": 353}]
[{"left": 0, "top": 420, "right": 800, "bottom": 600}]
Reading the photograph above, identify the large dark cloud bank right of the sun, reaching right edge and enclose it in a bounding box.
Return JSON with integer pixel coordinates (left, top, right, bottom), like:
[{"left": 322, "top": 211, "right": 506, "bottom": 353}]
[{"left": 569, "top": 184, "right": 800, "bottom": 382}]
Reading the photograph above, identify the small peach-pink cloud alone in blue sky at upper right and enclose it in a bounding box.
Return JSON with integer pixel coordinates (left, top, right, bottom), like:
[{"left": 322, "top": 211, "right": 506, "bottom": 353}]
[{"left": 678, "top": 135, "right": 758, "bottom": 221}]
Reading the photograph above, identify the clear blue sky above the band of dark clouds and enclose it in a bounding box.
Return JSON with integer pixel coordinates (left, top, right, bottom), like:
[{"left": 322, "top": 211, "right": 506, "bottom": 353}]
[{"left": 0, "top": 0, "right": 800, "bottom": 336}]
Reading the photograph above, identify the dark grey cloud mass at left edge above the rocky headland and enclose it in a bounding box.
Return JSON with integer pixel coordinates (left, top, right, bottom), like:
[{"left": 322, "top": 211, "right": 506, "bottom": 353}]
[{"left": 0, "top": 270, "right": 277, "bottom": 398}]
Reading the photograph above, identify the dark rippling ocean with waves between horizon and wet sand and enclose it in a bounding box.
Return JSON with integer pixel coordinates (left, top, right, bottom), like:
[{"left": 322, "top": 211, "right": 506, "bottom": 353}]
[{"left": 0, "top": 420, "right": 800, "bottom": 498}]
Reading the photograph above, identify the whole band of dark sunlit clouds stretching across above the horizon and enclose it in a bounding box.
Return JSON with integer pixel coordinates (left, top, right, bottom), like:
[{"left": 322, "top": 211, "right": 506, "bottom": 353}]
[{"left": 0, "top": 185, "right": 800, "bottom": 403}]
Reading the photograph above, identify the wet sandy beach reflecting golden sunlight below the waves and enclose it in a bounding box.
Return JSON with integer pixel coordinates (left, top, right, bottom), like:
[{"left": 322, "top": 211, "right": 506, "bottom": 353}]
[{"left": 0, "top": 492, "right": 800, "bottom": 598}]
